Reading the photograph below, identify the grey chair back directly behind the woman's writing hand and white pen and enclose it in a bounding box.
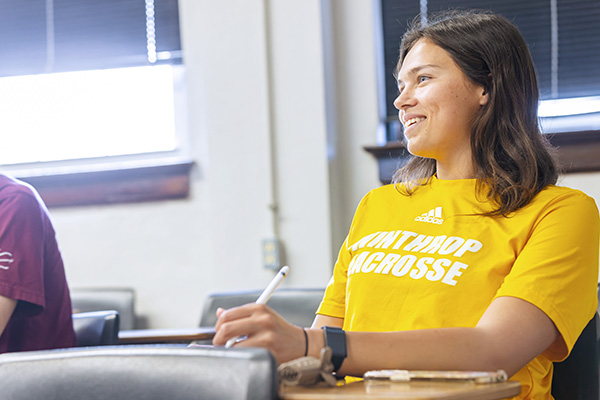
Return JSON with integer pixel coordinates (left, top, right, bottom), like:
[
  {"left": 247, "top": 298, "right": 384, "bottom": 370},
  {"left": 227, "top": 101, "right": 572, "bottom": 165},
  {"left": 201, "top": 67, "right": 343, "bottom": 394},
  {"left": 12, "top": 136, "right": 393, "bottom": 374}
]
[{"left": 200, "top": 288, "right": 325, "bottom": 327}]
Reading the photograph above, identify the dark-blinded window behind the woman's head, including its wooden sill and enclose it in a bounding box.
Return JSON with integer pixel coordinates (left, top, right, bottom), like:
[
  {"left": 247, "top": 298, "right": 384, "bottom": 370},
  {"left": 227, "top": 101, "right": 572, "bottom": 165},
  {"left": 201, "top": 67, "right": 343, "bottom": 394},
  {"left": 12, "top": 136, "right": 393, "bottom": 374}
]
[{"left": 366, "top": 0, "right": 600, "bottom": 183}]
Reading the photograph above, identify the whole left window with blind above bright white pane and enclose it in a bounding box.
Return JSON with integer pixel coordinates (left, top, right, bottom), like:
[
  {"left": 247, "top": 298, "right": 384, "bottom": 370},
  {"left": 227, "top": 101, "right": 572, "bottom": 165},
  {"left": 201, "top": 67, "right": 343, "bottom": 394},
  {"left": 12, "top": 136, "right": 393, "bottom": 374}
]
[{"left": 0, "top": 0, "right": 189, "bottom": 206}]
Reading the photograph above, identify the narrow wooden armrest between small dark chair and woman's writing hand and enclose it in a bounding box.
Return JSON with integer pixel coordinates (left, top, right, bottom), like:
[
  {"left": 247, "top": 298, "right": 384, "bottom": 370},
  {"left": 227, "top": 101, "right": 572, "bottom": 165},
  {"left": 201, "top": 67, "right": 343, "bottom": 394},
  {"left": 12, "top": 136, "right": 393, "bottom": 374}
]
[{"left": 119, "top": 326, "right": 215, "bottom": 344}]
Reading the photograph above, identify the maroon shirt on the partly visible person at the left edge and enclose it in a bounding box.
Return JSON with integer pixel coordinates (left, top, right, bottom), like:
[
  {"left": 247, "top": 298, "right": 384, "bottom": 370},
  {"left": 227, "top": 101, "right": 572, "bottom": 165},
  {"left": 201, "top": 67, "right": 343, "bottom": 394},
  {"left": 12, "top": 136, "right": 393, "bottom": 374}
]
[{"left": 0, "top": 175, "right": 75, "bottom": 353}]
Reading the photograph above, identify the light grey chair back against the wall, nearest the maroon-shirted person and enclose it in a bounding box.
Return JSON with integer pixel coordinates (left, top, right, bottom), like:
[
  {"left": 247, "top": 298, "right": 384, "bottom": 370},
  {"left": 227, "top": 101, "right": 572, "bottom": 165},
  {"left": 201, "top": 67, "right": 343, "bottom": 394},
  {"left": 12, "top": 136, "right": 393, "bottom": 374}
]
[{"left": 70, "top": 287, "right": 138, "bottom": 330}]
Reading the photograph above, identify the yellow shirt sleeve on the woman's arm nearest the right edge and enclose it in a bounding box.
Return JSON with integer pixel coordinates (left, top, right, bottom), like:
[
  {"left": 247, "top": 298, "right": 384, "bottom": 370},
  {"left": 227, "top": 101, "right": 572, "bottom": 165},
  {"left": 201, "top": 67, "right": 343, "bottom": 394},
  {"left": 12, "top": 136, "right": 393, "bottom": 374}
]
[{"left": 496, "top": 191, "right": 600, "bottom": 361}]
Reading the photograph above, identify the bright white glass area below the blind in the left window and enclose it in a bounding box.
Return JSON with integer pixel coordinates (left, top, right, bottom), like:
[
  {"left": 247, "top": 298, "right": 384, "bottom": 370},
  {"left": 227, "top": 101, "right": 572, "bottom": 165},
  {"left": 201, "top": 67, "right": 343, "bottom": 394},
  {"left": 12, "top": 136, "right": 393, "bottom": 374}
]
[{"left": 0, "top": 65, "right": 177, "bottom": 164}]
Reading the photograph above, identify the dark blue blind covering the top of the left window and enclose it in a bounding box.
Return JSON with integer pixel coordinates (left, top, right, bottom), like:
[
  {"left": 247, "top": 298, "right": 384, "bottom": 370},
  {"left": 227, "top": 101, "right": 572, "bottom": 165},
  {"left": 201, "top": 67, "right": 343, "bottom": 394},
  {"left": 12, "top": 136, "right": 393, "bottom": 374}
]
[{"left": 0, "top": 0, "right": 182, "bottom": 76}]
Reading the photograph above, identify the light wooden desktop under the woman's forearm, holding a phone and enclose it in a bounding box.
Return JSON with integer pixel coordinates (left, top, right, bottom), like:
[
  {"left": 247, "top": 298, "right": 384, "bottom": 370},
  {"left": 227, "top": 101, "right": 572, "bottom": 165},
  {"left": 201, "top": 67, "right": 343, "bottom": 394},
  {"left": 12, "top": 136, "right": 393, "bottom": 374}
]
[{"left": 280, "top": 381, "right": 521, "bottom": 400}]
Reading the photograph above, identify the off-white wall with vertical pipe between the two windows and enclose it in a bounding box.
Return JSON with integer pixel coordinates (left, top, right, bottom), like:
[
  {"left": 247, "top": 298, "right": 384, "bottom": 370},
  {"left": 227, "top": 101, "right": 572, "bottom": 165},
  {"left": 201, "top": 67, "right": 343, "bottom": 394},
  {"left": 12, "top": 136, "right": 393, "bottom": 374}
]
[{"left": 51, "top": 0, "right": 600, "bottom": 327}]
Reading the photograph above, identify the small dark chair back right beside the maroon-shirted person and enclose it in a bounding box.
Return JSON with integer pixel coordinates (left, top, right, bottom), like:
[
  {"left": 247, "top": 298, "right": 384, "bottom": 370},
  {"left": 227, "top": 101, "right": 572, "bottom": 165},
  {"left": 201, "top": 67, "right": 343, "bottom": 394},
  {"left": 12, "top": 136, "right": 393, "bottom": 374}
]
[{"left": 73, "top": 310, "right": 119, "bottom": 347}]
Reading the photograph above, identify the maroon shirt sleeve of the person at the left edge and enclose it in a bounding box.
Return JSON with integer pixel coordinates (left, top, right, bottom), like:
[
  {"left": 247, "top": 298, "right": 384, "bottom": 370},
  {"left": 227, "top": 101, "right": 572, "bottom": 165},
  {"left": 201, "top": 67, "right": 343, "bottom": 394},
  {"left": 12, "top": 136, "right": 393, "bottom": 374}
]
[{"left": 0, "top": 192, "right": 45, "bottom": 312}]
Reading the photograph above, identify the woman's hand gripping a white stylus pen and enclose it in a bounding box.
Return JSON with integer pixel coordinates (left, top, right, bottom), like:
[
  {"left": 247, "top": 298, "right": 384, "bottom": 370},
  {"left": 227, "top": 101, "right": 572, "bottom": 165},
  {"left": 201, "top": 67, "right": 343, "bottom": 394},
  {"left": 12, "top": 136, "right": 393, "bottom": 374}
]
[{"left": 213, "top": 303, "right": 306, "bottom": 363}]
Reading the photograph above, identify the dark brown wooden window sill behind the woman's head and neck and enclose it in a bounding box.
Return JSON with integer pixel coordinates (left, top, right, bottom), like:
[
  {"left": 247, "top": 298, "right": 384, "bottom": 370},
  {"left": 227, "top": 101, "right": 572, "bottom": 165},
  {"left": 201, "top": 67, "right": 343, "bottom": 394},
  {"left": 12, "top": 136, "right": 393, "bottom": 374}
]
[{"left": 364, "top": 131, "right": 600, "bottom": 184}]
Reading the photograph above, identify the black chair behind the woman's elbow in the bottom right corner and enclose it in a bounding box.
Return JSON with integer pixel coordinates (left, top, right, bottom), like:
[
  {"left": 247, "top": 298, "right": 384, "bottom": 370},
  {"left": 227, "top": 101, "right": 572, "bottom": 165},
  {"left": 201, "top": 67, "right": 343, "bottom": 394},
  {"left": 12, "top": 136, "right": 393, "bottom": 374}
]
[{"left": 552, "top": 313, "right": 600, "bottom": 400}]
